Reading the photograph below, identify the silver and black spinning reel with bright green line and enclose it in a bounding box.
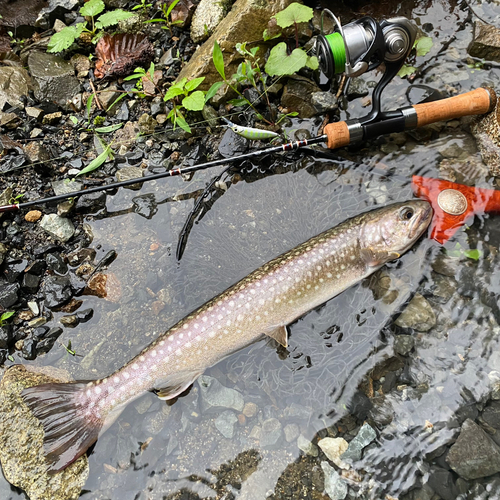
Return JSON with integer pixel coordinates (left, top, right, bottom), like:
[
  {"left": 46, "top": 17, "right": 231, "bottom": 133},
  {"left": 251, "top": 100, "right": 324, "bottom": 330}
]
[{"left": 315, "top": 9, "right": 417, "bottom": 124}]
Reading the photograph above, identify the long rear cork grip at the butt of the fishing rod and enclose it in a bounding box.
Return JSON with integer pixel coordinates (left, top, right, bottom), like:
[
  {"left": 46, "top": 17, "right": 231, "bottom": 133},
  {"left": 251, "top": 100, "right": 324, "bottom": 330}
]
[{"left": 413, "top": 88, "right": 497, "bottom": 127}]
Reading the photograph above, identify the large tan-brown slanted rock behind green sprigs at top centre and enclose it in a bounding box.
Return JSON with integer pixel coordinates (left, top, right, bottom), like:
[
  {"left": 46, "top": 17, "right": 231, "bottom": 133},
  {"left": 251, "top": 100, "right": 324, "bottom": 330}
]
[{"left": 177, "top": 0, "right": 293, "bottom": 90}]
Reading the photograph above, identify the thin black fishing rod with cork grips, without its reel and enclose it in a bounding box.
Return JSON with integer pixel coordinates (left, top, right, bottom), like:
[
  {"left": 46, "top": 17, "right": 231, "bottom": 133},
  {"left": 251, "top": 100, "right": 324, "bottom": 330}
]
[{"left": 0, "top": 88, "right": 497, "bottom": 213}]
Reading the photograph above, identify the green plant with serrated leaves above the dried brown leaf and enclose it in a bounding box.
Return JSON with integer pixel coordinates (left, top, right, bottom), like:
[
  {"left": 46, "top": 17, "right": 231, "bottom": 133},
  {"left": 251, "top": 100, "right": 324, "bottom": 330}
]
[{"left": 47, "top": 0, "right": 134, "bottom": 52}]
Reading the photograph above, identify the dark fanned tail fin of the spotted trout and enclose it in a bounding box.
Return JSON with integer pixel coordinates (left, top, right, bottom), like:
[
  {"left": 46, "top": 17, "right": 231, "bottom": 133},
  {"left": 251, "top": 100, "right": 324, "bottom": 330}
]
[{"left": 21, "top": 382, "right": 104, "bottom": 473}]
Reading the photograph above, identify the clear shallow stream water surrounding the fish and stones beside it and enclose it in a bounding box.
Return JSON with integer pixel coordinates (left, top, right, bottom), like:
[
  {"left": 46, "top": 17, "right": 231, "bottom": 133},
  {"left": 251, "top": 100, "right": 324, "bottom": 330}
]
[{"left": 0, "top": 2, "right": 500, "bottom": 500}]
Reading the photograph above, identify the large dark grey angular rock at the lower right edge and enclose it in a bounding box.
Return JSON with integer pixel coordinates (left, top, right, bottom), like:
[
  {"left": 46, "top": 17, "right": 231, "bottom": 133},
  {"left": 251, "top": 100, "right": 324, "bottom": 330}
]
[{"left": 446, "top": 419, "right": 500, "bottom": 480}]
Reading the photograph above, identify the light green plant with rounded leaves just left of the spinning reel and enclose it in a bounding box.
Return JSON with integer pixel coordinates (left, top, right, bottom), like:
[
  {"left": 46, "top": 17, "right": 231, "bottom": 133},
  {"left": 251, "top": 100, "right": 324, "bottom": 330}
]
[{"left": 263, "top": 3, "right": 319, "bottom": 76}]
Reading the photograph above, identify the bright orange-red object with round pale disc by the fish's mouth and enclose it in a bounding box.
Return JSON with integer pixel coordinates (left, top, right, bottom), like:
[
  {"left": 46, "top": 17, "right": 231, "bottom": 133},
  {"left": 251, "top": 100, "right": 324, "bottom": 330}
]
[{"left": 412, "top": 175, "right": 500, "bottom": 244}]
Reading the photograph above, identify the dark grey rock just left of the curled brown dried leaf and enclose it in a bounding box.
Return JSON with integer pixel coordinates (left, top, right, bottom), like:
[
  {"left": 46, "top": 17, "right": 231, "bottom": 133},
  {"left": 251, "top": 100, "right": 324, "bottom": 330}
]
[{"left": 28, "top": 51, "right": 80, "bottom": 108}]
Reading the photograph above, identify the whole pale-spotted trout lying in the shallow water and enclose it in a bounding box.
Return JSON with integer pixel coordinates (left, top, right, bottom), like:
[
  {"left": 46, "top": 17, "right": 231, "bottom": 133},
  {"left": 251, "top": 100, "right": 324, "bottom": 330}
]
[{"left": 22, "top": 200, "right": 433, "bottom": 473}]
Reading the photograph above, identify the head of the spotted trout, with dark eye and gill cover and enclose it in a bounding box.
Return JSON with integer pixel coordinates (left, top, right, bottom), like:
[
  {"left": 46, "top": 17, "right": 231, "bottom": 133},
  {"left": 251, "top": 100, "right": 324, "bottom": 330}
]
[{"left": 360, "top": 200, "right": 433, "bottom": 265}]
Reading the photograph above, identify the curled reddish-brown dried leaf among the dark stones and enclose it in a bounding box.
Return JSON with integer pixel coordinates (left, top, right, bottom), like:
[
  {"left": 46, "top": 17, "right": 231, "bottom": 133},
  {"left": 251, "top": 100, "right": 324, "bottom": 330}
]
[{"left": 94, "top": 33, "right": 154, "bottom": 78}]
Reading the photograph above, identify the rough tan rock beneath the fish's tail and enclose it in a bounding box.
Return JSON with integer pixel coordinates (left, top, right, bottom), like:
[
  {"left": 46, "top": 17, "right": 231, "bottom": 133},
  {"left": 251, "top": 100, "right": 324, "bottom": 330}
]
[{"left": 0, "top": 365, "right": 89, "bottom": 500}]
